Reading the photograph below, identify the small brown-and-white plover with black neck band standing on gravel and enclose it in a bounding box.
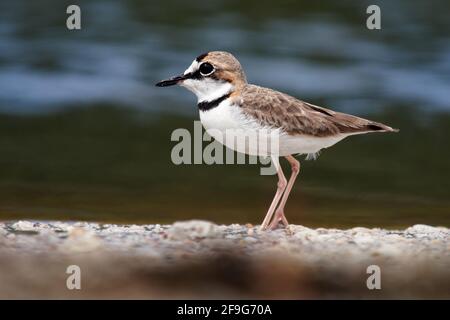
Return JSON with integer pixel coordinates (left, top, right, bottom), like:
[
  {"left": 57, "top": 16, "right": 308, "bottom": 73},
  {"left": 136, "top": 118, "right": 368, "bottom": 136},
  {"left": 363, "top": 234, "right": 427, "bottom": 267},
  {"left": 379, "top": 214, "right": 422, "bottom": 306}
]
[{"left": 156, "top": 51, "right": 398, "bottom": 230}]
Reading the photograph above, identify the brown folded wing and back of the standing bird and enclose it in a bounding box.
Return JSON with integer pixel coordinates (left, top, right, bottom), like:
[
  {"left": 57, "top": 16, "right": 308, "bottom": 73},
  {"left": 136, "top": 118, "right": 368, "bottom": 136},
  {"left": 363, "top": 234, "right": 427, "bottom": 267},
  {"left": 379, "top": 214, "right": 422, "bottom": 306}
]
[{"left": 240, "top": 85, "right": 395, "bottom": 137}]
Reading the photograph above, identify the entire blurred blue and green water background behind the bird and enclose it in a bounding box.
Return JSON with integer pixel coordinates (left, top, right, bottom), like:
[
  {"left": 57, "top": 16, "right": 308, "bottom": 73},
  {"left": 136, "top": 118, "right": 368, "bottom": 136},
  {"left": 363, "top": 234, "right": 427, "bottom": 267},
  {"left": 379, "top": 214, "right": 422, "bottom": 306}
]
[{"left": 0, "top": 0, "right": 450, "bottom": 227}]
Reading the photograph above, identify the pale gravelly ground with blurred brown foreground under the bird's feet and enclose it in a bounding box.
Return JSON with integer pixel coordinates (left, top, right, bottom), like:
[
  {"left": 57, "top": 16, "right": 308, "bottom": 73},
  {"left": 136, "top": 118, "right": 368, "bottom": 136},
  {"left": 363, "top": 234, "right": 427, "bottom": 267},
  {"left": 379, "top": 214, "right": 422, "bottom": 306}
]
[{"left": 0, "top": 220, "right": 450, "bottom": 298}]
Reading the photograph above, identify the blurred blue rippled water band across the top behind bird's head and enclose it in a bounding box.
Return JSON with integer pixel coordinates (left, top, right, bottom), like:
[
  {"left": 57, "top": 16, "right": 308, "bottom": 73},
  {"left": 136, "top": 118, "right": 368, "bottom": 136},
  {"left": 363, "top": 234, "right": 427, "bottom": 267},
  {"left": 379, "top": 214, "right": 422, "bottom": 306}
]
[{"left": 0, "top": 1, "right": 450, "bottom": 113}]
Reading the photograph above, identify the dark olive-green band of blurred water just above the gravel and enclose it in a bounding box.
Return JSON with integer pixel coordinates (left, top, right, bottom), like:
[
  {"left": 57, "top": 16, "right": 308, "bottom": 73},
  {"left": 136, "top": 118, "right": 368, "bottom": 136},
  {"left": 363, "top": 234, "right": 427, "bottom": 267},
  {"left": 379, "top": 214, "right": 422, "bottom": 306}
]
[{"left": 0, "top": 106, "right": 450, "bottom": 227}]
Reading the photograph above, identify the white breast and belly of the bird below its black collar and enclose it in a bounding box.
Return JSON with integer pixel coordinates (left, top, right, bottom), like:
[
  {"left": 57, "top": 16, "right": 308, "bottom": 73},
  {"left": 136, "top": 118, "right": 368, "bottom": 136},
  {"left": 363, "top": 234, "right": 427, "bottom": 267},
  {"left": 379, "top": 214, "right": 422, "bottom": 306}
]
[{"left": 200, "top": 99, "right": 345, "bottom": 156}]
